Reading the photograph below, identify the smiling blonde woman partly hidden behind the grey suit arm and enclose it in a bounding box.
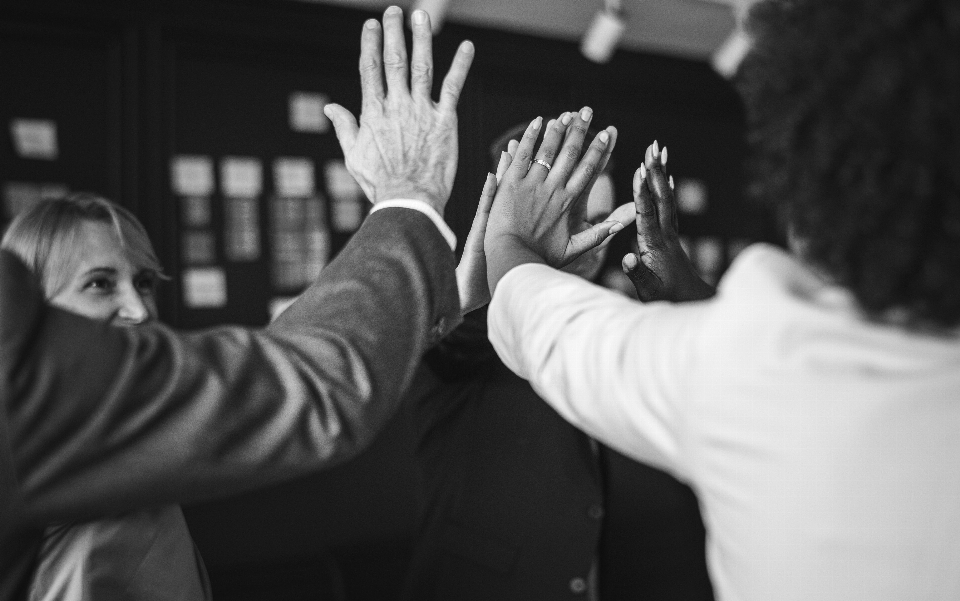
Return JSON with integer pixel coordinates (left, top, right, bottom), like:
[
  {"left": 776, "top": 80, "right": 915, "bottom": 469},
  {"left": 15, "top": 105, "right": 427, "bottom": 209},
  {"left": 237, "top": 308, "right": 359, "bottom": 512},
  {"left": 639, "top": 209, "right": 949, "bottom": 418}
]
[{"left": 0, "top": 194, "right": 210, "bottom": 601}]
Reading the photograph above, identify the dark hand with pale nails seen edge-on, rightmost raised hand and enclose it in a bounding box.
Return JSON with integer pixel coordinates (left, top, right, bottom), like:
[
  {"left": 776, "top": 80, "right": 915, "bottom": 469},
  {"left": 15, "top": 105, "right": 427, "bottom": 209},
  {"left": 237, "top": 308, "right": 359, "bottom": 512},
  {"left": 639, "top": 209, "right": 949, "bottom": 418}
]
[{"left": 622, "top": 142, "right": 716, "bottom": 302}]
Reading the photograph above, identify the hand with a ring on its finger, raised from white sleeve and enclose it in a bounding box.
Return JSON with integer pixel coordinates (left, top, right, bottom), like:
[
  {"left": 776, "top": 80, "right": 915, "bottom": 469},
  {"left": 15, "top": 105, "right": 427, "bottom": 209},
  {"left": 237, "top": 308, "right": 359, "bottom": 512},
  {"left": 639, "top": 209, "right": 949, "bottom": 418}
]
[{"left": 485, "top": 108, "right": 623, "bottom": 290}]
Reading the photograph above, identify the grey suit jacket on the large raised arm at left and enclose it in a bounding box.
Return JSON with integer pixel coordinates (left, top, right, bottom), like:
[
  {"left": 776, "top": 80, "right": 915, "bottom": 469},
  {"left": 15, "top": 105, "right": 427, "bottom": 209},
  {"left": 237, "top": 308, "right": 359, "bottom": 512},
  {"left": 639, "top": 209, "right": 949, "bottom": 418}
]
[{"left": 0, "top": 208, "right": 459, "bottom": 599}]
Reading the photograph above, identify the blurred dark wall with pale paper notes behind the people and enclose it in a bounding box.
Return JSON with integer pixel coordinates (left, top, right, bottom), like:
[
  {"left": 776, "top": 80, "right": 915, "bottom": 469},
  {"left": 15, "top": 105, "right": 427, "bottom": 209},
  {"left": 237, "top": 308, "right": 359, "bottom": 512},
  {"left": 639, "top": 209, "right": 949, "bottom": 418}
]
[{"left": 0, "top": 0, "right": 776, "bottom": 599}]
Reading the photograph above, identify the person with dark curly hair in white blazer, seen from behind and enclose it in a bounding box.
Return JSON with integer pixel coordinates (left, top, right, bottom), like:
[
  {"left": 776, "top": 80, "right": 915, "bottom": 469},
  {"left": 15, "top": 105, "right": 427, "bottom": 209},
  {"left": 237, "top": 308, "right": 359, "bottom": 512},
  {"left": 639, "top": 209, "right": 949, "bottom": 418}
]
[{"left": 486, "top": 0, "right": 960, "bottom": 601}]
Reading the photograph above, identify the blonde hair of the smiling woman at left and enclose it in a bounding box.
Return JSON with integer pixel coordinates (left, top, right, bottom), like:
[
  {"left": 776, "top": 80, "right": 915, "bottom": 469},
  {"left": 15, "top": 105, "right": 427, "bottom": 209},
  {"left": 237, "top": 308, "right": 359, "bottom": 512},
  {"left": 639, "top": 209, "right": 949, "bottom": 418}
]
[{"left": 0, "top": 193, "right": 164, "bottom": 298}]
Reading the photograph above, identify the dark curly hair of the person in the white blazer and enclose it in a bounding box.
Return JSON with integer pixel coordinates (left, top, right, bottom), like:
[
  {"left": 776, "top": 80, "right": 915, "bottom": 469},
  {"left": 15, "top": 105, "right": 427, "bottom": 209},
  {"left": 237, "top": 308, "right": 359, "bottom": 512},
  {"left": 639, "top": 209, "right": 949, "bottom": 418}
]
[{"left": 737, "top": 0, "right": 960, "bottom": 328}]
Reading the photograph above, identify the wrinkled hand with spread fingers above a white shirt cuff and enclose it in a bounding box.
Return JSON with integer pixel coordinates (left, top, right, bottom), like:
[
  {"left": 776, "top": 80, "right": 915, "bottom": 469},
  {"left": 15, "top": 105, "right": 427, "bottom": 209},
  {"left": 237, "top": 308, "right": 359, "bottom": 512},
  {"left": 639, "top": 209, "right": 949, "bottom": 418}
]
[{"left": 324, "top": 6, "right": 474, "bottom": 215}]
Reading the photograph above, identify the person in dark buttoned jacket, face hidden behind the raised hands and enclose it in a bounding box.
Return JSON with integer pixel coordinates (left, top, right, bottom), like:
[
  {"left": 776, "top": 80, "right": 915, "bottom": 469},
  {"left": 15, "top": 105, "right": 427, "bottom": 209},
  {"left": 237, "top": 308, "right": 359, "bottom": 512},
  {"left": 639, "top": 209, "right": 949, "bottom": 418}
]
[{"left": 401, "top": 126, "right": 713, "bottom": 601}]
